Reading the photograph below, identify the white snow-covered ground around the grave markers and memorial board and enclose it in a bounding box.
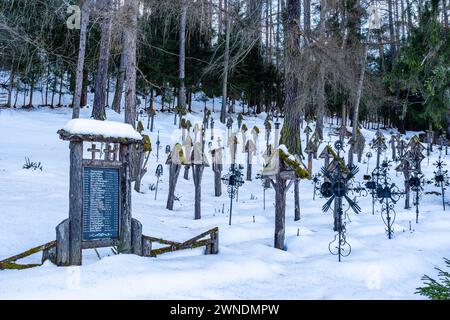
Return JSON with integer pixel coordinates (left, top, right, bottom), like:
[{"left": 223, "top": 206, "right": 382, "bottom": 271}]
[{"left": 0, "top": 99, "right": 450, "bottom": 299}]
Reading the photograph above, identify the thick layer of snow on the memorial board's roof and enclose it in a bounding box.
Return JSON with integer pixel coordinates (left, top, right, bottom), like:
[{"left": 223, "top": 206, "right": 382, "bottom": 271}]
[{"left": 58, "top": 119, "right": 142, "bottom": 142}]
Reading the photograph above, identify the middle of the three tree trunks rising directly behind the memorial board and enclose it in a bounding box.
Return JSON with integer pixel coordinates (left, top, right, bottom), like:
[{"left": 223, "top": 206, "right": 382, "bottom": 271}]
[{"left": 92, "top": 0, "right": 112, "bottom": 120}]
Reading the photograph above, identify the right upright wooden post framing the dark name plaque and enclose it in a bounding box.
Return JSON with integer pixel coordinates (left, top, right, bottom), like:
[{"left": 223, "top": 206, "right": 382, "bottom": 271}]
[{"left": 119, "top": 144, "right": 132, "bottom": 253}]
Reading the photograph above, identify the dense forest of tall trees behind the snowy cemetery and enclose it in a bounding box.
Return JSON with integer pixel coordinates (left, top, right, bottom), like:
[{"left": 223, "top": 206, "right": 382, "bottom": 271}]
[{"left": 0, "top": 0, "right": 450, "bottom": 138}]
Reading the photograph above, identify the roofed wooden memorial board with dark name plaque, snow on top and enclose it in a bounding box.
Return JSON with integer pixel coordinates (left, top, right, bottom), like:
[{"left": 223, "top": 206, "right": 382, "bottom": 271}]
[{"left": 56, "top": 119, "right": 143, "bottom": 266}]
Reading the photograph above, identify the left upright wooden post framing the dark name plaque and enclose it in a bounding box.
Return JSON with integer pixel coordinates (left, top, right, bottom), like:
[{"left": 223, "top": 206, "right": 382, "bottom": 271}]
[{"left": 69, "top": 141, "right": 83, "bottom": 266}]
